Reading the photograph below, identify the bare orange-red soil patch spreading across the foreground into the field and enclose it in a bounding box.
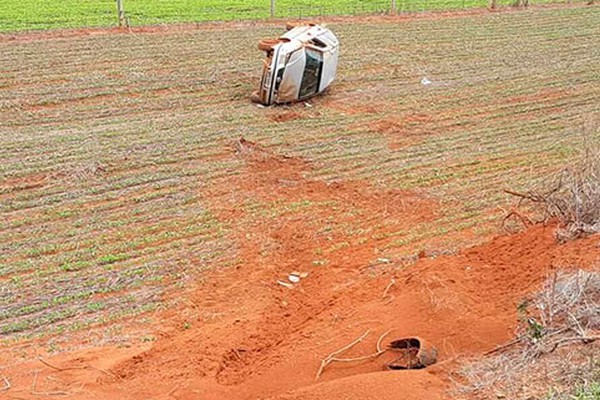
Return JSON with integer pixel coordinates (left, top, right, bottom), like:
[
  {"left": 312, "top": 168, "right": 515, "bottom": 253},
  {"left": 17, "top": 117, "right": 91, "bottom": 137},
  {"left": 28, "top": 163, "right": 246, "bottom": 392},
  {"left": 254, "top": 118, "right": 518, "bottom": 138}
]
[{"left": 0, "top": 139, "right": 599, "bottom": 400}]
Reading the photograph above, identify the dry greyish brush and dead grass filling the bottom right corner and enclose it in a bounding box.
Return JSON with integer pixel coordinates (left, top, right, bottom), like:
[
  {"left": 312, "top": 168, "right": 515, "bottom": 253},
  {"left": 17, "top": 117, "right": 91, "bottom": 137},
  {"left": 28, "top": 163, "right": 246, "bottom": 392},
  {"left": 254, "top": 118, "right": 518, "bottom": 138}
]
[{"left": 455, "top": 271, "right": 600, "bottom": 400}]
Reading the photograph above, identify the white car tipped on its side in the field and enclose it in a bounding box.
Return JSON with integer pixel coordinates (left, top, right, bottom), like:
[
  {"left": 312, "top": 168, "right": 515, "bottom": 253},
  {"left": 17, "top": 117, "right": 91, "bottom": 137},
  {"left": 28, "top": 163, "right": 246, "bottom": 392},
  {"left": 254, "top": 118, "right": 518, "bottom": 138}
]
[{"left": 252, "top": 24, "right": 339, "bottom": 105}]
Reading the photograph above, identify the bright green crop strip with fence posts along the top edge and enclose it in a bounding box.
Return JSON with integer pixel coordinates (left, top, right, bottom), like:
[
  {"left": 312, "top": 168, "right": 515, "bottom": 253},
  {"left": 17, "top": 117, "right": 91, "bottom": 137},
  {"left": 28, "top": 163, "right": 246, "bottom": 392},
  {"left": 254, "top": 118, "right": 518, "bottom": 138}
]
[{"left": 0, "top": 0, "right": 598, "bottom": 32}]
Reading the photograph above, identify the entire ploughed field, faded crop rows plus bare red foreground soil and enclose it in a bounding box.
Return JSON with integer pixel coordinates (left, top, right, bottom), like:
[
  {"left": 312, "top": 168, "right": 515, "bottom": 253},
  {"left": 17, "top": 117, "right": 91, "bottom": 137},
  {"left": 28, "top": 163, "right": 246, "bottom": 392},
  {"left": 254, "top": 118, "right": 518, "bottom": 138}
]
[{"left": 0, "top": 6, "right": 600, "bottom": 399}]
